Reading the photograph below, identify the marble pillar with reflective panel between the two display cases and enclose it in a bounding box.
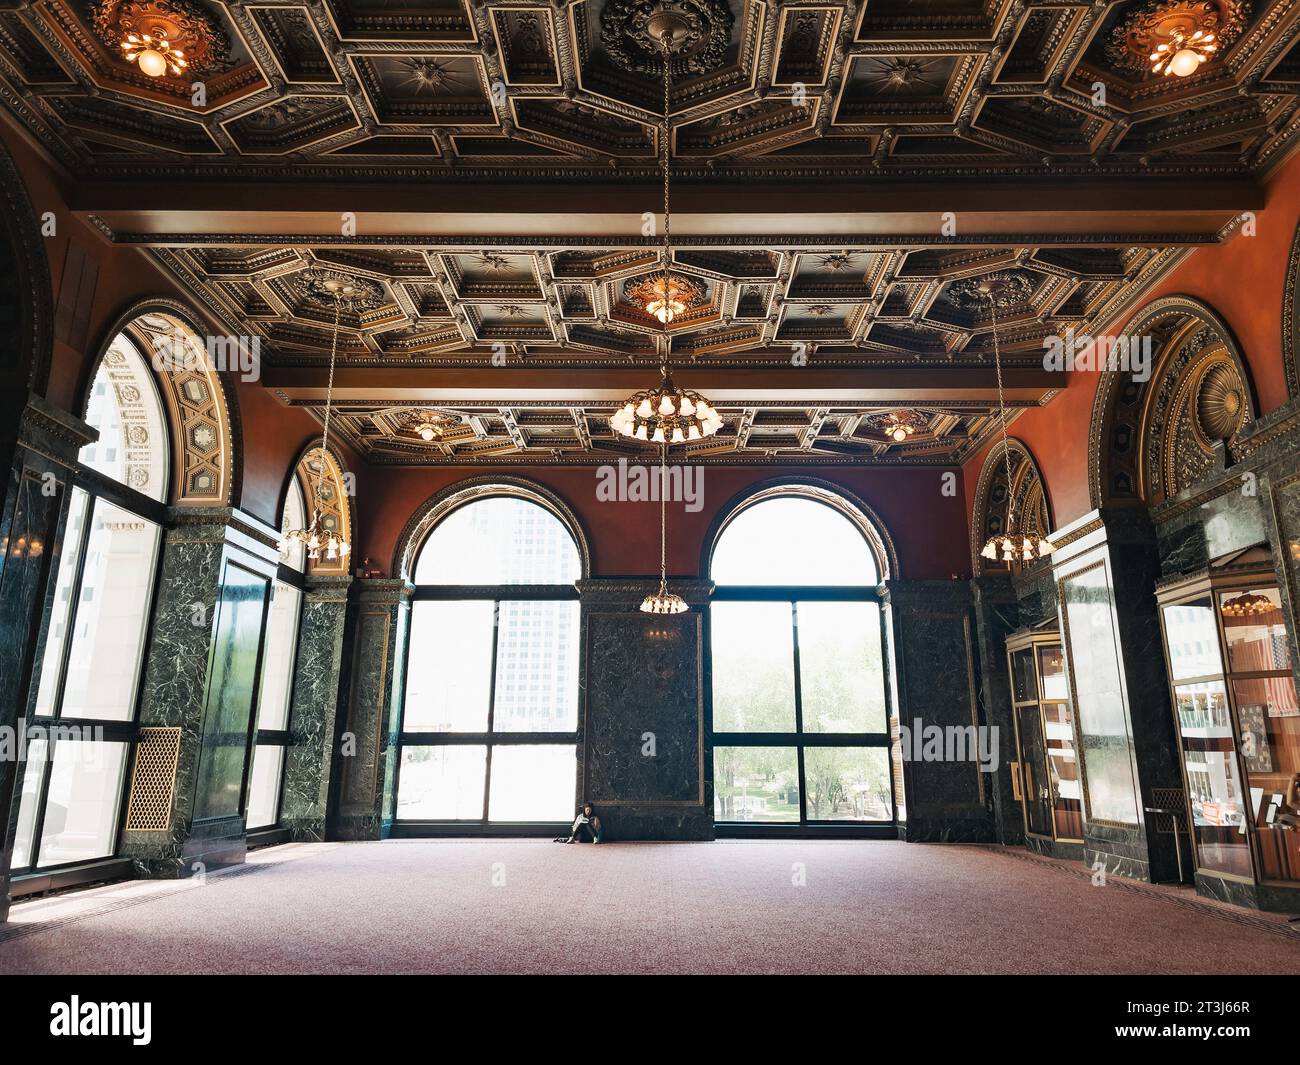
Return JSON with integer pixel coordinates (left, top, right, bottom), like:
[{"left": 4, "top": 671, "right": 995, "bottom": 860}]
[{"left": 1052, "top": 507, "right": 1182, "bottom": 880}]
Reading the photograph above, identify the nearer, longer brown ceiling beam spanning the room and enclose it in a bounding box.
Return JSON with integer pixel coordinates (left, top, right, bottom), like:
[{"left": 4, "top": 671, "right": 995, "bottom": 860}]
[{"left": 78, "top": 178, "right": 1264, "bottom": 246}]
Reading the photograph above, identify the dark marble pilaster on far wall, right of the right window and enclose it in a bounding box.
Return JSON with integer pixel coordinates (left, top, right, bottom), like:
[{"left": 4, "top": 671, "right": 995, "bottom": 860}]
[{"left": 884, "top": 580, "right": 998, "bottom": 843}]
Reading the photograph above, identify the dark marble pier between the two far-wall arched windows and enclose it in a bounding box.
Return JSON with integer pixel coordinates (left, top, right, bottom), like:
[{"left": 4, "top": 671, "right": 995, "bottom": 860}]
[{"left": 577, "top": 579, "right": 714, "bottom": 840}]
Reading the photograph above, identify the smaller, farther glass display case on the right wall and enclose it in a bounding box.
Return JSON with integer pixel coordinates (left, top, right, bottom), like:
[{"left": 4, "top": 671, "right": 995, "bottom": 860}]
[{"left": 1006, "top": 631, "right": 1083, "bottom": 857}]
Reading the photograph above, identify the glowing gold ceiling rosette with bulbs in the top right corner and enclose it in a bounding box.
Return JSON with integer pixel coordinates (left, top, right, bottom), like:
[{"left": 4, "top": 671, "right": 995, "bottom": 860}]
[{"left": 1108, "top": 0, "right": 1249, "bottom": 78}]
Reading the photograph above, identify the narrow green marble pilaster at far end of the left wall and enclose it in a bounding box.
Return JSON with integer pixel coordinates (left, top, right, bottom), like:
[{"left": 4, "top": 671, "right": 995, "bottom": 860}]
[{"left": 280, "top": 577, "right": 352, "bottom": 843}]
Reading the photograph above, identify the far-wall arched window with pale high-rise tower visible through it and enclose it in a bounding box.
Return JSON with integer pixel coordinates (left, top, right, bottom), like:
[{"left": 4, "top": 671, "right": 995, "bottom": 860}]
[{"left": 397, "top": 489, "right": 582, "bottom": 826}]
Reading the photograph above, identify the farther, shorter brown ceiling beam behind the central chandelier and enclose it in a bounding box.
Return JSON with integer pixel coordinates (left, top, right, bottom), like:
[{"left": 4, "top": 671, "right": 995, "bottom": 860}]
[{"left": 261, "top": 364, "right": 1067, "bottom": 406}]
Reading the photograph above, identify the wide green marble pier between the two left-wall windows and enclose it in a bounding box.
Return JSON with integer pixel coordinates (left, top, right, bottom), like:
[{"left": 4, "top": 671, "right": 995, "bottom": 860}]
[{"left": 122, "top": 507, "right": 278, "bottom": 878}]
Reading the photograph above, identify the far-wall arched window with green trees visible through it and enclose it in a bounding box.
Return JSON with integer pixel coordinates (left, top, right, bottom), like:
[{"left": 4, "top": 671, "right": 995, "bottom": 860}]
[{"left": 710, "top": 486, "right": 894, "bottom": 832}]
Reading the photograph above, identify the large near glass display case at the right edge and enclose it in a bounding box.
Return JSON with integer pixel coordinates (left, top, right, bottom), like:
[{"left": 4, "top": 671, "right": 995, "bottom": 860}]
[{"left": 1158, "top": 547, "right": 1300, "bottom": 910}]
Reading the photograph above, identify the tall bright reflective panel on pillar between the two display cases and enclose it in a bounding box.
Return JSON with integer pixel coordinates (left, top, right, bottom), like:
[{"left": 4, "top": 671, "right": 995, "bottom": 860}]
[{"left": 1061, "top": 566, "right": 1140, "bottom": 824}]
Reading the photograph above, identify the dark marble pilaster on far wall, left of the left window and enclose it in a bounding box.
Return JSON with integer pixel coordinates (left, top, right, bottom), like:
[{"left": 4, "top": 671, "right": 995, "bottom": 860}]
[{"left": 328, "top": 579, "right": 413, "bottom": 840}]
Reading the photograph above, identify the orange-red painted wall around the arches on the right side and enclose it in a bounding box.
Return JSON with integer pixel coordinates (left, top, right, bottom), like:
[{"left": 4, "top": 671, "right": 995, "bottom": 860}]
[{"left": 962, "top": 143, "right": 1300, "bottom": 528}]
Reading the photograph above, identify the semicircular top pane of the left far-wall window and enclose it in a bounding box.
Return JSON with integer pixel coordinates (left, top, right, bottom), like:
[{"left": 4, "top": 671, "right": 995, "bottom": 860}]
[{"left": 415, "top": 497, "right": 582, "bottom": 584}]
